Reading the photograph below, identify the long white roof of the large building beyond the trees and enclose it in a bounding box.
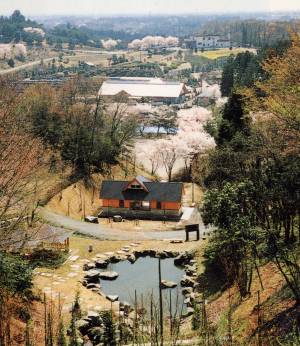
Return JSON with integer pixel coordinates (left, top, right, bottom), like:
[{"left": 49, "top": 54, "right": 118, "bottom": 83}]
[{"left": 99, "top": 77, "right": 184, "bottom": 98}]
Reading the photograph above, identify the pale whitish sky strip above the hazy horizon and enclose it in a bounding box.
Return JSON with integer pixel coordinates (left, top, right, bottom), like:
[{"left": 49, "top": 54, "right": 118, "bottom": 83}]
[{"left": 0, "top": 0, "right": 300, "bottom": 15}]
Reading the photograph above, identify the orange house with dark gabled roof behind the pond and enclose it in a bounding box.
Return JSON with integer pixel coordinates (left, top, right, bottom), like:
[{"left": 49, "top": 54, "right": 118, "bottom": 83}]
[{"left": 100, "top": 176, "right": 183, "bottom": 220}]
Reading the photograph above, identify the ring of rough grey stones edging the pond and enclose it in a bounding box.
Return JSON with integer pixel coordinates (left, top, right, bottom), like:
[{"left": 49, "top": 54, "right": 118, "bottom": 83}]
[{"left": 82, "top": 247, "right": 198, "bottom": 317}]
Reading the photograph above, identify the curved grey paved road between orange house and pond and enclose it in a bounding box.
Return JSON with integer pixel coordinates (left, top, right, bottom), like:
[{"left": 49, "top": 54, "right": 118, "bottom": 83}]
[{"left": 40, "top": 209, "right": 212, "bottom": 240}]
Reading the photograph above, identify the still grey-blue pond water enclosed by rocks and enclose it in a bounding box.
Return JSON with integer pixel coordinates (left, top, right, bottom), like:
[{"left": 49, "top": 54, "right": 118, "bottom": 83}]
[{"left": 100, "top": 256, "right": 184, "bottom": 310}]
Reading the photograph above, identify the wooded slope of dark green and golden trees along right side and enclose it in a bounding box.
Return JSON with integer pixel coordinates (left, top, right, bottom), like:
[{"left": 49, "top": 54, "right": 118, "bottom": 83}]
[{"left": 194, "top": 34, "right": 300, "bottom": 345}]
